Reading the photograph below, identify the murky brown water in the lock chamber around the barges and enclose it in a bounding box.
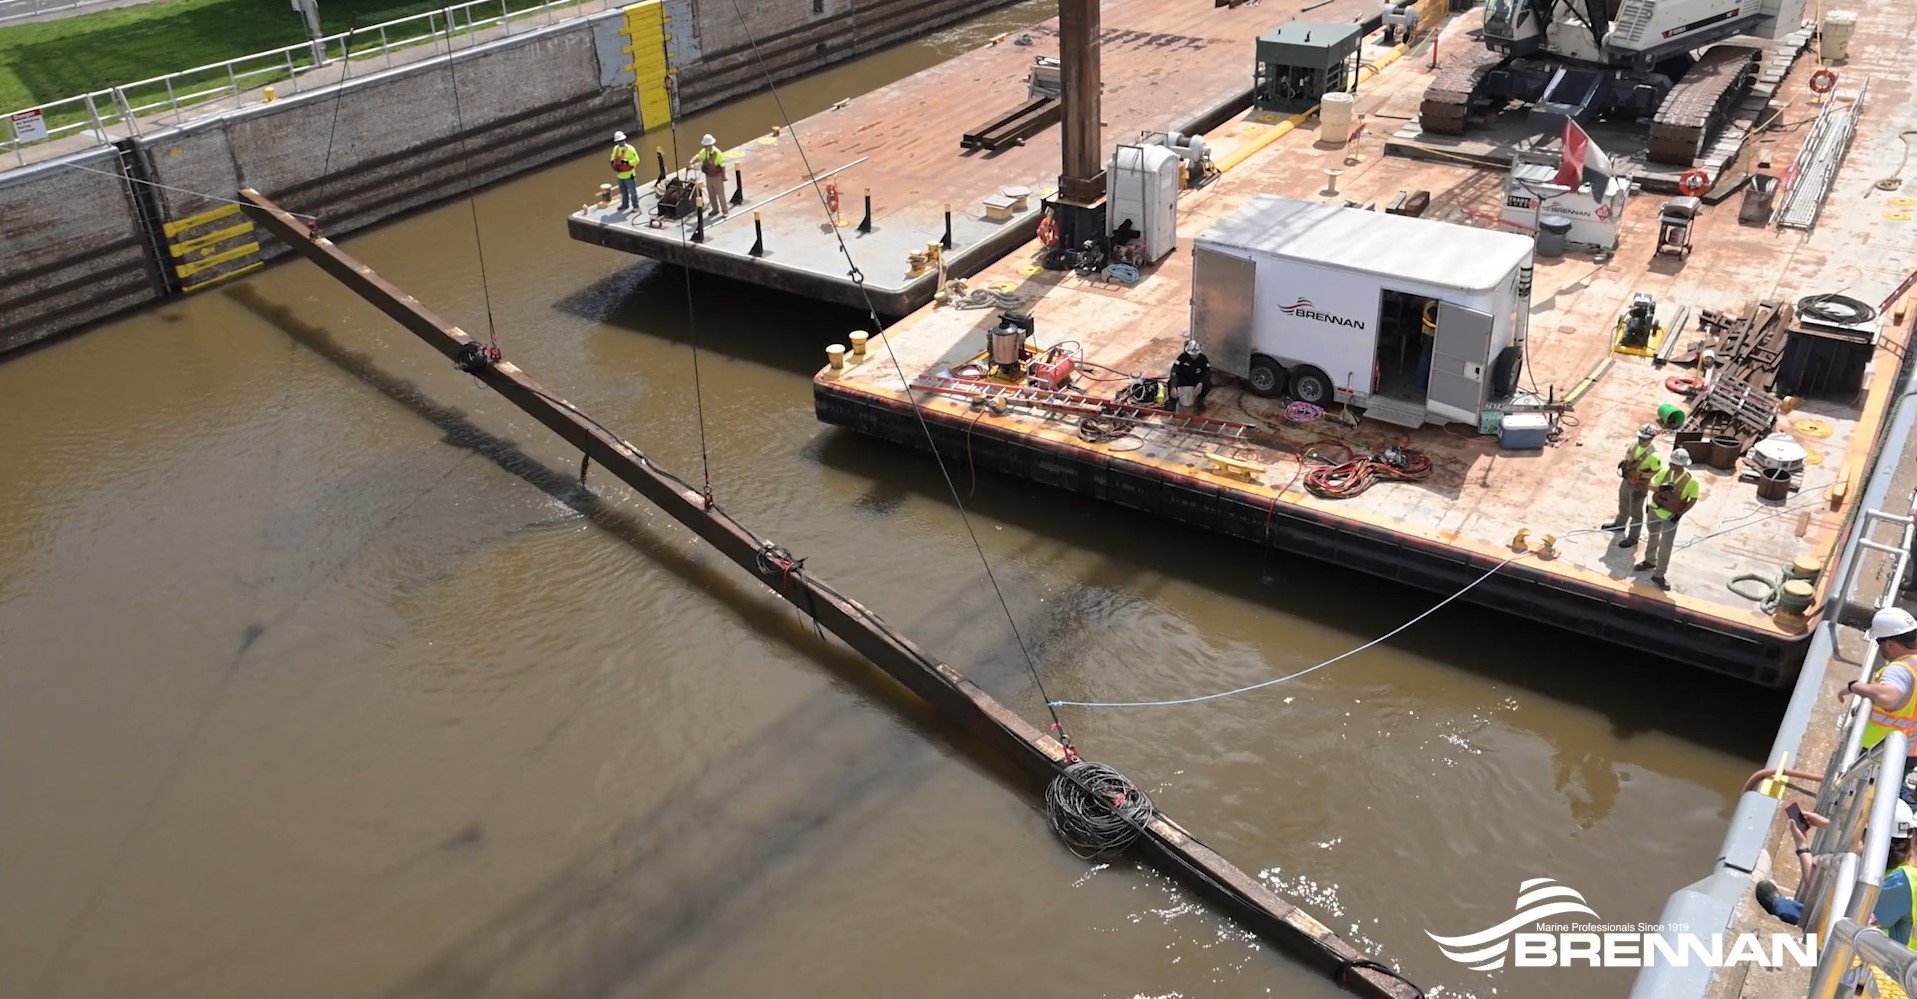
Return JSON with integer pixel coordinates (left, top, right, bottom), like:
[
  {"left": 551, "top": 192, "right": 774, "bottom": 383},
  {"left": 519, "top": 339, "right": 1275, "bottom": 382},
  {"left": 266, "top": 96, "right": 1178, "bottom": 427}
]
[{"left": 0, "top": 4, "right": 1781, "bottom": 997}]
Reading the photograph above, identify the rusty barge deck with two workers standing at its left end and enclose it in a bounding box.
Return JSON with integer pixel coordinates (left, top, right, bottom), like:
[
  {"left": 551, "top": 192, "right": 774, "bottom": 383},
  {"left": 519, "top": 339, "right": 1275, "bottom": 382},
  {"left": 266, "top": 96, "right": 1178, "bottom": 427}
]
[{"left": 566, "top": 0, "right": 1395, "bottom": 316}]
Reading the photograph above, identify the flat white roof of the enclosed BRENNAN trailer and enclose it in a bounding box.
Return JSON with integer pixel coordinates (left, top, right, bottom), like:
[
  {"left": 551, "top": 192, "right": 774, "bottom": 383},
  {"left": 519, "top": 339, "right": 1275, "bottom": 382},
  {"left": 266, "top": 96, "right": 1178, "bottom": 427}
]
[{"left": 1198, "top": 194, "right": 1532, "bottom": 291}]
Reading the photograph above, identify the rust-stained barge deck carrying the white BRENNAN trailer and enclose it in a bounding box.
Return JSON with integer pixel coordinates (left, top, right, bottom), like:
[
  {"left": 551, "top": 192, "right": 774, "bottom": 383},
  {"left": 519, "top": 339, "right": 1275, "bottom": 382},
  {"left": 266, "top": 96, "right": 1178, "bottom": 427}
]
[{"left": 815, "top": 17, "right": 1913, "bottom": 696}]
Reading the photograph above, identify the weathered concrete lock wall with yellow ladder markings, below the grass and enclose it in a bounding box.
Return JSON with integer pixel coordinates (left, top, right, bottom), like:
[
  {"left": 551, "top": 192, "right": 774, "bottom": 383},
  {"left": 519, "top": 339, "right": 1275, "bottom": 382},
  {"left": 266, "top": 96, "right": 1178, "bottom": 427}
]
[{"left": 0, "top": 0, "right": 1012, "bottom": 351}]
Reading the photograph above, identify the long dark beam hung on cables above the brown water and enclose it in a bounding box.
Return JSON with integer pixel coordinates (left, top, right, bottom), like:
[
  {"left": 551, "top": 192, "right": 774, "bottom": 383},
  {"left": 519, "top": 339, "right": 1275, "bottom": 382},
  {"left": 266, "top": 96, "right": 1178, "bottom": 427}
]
[{"left": 240, "top": 188, "right": 1419, "bottom": 999}]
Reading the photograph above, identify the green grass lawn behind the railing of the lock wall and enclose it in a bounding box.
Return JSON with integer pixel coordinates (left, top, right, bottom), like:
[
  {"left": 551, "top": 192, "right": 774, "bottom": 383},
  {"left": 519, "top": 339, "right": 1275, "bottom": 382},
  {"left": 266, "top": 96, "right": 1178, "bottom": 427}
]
[{"left": 0, "top": 0, "right": 479, "bottom": 114}]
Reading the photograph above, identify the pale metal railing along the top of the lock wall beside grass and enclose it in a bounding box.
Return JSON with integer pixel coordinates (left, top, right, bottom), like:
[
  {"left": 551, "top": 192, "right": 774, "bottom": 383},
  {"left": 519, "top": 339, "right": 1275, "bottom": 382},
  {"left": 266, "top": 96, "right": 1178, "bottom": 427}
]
[{"left": 0, "top": 0, "right": 617, "bottom": 165}]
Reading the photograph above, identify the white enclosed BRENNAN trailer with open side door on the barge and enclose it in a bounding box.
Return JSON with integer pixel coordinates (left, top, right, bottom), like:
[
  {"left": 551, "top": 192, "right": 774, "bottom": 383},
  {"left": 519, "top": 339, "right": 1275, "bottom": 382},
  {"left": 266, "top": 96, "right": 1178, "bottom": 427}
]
[{"left": 1192, "top": 196, "right": 1532, "bottom": 426}]
